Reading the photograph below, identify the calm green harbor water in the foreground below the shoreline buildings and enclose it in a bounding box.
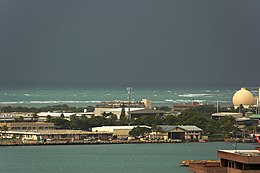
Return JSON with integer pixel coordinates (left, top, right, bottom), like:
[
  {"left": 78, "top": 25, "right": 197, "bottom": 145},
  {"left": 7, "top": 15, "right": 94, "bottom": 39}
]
[{"left": 0, "top": 142, "right": 257, "bottom": 173}]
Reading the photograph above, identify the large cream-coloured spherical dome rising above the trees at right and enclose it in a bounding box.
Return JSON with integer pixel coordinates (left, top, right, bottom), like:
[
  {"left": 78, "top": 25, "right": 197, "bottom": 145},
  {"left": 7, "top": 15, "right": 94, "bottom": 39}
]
[{"left": 233, "top": 88, "right": 255, "bottom": 108}]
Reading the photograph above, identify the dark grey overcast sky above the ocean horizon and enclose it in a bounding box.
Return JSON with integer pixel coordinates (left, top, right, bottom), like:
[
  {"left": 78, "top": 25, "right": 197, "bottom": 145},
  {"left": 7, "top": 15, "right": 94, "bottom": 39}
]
[{"left": 0, "top": 0, "right": 260, "bottom": 86}]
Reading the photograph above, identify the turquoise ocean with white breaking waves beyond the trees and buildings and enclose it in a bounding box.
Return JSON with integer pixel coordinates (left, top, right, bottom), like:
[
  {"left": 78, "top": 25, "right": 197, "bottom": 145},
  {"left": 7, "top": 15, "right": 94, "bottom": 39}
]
[{"left": 0, "top": 87, "right": 242, "bottom": 107}]
